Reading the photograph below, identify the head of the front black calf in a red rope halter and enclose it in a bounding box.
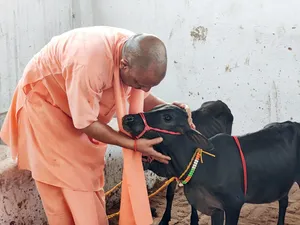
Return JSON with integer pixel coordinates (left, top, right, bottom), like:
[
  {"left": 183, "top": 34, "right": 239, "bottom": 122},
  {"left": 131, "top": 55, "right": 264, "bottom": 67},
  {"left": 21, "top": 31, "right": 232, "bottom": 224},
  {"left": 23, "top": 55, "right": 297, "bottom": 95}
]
[{"left": 122, "top": 104, "right": 213, "bottom": 177}]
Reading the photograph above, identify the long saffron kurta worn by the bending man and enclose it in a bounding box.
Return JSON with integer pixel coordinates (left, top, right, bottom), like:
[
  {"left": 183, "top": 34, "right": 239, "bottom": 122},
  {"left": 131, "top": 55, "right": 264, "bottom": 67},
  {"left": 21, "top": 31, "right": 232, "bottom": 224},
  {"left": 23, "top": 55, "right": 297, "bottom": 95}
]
[{"left": 0, "top": 26, "right": 149, "bottom": 224}]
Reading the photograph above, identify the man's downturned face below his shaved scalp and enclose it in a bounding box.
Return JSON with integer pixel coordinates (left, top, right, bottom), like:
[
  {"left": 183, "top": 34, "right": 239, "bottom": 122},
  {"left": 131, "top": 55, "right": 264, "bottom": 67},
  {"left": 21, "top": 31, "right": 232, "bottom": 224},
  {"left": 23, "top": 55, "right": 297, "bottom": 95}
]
[{"left": 120, "top": 59, "right": 162, "bottom": 92}]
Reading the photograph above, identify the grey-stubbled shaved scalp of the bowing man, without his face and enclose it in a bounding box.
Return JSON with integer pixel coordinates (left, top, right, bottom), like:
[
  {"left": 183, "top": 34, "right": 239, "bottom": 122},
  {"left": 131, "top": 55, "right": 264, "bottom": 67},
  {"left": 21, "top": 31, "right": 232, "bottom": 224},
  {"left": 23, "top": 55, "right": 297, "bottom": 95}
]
[{"left": 122, "top": 34, "right": 167, "bottom": 78}]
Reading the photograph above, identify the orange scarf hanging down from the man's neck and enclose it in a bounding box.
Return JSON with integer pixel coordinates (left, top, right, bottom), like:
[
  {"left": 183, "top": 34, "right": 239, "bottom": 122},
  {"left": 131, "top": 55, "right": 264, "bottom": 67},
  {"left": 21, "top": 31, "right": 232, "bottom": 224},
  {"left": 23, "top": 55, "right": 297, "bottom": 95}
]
[{"left": 114, "top": 40, "right": 153, "bottom": 225}]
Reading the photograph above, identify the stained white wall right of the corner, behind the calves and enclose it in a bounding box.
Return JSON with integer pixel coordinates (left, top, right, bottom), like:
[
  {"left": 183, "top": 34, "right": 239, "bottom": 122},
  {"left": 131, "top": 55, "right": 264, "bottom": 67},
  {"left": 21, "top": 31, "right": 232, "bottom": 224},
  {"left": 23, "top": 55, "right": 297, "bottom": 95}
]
[{"left": 95, "top": 0, "right": 300, "bottom": 134}]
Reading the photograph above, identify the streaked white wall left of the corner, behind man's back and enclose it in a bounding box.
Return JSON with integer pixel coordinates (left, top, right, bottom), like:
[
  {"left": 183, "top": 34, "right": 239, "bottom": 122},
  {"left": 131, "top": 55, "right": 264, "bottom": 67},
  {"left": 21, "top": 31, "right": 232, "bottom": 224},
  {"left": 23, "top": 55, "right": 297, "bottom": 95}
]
[{"left": 0, "top": 0, "right": 94, "bottom": 115}]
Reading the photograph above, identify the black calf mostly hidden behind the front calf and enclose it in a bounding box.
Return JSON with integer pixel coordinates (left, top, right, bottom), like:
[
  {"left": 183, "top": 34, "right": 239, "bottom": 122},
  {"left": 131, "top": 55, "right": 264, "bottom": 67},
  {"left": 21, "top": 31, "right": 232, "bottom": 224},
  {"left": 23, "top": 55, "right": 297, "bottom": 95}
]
[{"left": 143, "top": 100, "right": 234, "bottom": 225}]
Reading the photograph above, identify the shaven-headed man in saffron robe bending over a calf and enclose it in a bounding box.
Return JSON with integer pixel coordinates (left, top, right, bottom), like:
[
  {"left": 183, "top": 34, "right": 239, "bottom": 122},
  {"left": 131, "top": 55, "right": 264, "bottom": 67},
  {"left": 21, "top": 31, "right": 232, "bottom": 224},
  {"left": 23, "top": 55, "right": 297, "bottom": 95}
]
[{"left": 0, "top": 26, "right": 196, "bottom": 225}]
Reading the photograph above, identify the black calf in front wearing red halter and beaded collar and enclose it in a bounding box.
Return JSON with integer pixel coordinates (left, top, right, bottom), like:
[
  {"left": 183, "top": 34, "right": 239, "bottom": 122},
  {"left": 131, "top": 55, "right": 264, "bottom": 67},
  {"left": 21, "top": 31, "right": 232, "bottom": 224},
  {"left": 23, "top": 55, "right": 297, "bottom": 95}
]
[{"left": 123, "top": 105, "right": 300, "bottom": 225}]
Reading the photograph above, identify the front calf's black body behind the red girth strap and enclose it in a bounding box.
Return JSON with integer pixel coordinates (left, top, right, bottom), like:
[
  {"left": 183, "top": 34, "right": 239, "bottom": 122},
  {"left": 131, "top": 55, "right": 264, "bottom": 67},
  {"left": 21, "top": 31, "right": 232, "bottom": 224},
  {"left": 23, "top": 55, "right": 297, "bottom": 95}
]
[{"left": 231, "top": 121, "right": 299, "bottom": 204}]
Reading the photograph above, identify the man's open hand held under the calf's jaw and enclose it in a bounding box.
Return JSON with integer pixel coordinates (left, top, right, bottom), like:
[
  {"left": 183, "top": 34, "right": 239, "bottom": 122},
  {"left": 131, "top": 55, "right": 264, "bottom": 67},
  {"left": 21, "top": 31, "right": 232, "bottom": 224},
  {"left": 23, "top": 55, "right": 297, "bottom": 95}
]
[{"left": 136, "top": 137, "right": 171, "bottom": 164}]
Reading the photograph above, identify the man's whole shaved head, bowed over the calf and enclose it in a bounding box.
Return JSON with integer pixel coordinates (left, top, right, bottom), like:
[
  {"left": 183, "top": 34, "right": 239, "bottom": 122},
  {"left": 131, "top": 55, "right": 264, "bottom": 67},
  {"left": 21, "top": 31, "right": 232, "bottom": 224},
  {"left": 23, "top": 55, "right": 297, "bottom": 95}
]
[{"left": 120, "top": 34, "right": 167, "bottom": 92}]
